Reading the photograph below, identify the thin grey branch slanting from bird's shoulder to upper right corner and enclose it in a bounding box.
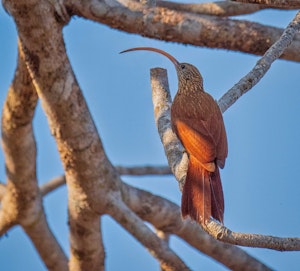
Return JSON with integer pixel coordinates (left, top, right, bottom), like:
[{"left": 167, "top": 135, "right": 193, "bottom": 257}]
[{"left": 218, "top": 12, "right": 300, "bottom": 112}]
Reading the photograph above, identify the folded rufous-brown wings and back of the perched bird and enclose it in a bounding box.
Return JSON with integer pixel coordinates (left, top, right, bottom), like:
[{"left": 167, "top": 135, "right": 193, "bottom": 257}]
[{"left": 172, "top": 92, "right": 227, "bottom": 171}]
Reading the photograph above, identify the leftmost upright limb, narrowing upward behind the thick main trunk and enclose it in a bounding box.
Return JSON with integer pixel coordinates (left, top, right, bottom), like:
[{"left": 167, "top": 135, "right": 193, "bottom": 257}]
[{"left": 0, "top": 39, "right": 68, "bottom": 270}]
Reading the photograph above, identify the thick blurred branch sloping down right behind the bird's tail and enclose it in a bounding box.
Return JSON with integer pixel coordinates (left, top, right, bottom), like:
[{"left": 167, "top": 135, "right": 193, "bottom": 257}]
[{"left": 122, "top": 183, "right": 270, "bottom": 271}]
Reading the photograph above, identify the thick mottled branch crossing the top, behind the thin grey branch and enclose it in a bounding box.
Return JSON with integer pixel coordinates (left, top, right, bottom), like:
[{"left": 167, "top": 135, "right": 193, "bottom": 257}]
[{"left": 68, "top": 0, "right": 300, "bottom": 61}]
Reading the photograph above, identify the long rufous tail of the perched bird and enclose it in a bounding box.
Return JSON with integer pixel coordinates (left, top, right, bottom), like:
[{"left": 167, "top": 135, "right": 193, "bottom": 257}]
[{"left": 181, "top": 156, "right": 224, "bottom": 224}]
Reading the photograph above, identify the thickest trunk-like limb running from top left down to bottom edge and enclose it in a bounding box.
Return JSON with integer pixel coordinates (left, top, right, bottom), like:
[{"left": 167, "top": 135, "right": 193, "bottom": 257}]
[{"left": 5, "top": 0, "right": 110, "bottom": 270}]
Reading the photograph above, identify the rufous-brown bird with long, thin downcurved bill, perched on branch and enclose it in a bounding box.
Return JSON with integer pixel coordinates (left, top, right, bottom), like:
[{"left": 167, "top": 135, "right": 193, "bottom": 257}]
[{"left": 121, "top": 47, "right": 228, "bottom": 225}]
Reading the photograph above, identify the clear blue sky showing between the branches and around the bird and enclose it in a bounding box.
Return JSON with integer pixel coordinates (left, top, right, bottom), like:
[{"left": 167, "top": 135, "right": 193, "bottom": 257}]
[{"left": 0, "top": 2, "right": 300, "bottom": 271}]
